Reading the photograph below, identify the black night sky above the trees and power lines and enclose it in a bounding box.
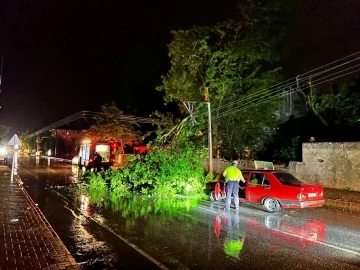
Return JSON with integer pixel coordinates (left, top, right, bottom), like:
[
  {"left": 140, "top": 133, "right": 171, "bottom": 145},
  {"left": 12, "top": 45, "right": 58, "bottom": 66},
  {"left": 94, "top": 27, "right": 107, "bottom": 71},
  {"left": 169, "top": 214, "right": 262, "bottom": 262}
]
[{"left": 0, "top": 0, "right": 360, "bottom": 135}]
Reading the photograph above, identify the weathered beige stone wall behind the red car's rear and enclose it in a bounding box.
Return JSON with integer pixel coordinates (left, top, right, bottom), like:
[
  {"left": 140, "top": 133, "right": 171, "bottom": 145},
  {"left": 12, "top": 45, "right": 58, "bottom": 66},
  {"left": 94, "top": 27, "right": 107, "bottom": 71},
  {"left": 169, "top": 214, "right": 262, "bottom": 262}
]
[{"left": 289, "top": 142, "right": 360, "bottom": 191}]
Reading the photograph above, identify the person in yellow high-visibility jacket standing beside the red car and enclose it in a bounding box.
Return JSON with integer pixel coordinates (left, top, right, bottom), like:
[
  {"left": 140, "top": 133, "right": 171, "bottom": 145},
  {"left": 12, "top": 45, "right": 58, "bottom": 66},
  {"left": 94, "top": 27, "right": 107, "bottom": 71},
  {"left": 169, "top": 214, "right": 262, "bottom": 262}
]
[{"left": 223, "top": 160, "right": 245, "bottom": 211}]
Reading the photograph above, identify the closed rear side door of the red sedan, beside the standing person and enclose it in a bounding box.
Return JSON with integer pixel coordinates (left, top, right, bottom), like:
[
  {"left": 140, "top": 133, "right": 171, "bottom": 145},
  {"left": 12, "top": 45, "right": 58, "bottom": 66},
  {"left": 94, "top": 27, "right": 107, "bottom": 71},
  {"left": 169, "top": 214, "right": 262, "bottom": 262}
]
[{"left": 246, "top": 172, "right": 271, "bottom": 203}]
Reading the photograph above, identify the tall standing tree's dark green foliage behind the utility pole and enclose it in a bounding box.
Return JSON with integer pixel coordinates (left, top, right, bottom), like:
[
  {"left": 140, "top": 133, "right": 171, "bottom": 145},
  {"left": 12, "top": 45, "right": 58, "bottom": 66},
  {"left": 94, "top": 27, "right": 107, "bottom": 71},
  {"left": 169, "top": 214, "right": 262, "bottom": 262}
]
[{"left": 157, "top": 0, "right": 298, "bottom": 158}]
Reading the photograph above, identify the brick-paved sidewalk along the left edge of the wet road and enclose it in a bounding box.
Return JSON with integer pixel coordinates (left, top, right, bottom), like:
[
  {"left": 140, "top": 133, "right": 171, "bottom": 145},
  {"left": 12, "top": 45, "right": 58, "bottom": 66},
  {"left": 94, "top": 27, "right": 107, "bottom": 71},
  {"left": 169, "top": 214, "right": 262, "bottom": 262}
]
[{"left": 0, "top": 166, "right": 80, "bottom": 270}]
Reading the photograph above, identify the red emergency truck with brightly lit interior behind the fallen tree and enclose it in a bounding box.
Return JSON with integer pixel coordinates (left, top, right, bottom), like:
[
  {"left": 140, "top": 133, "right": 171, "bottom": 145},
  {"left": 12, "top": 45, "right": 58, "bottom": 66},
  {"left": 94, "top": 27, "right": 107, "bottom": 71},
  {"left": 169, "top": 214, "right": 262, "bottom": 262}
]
[{"left": 72, "top": 140, "right": 118, "bottom": 170}]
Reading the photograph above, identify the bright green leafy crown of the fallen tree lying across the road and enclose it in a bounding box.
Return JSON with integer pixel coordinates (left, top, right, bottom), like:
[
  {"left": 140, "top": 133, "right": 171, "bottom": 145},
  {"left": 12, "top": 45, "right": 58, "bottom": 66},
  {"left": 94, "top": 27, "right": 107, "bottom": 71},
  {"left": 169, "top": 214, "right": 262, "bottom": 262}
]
[{"left": 84, "top": 135, "right": 205, "bottom": 198}]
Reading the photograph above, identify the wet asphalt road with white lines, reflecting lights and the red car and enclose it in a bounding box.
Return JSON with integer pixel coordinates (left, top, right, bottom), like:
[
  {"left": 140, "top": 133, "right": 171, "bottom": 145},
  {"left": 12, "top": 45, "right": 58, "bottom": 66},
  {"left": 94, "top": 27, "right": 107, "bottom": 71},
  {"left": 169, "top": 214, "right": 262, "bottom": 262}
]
[{"left": 19, "top": 158, "right": 360, "bottom": 269}]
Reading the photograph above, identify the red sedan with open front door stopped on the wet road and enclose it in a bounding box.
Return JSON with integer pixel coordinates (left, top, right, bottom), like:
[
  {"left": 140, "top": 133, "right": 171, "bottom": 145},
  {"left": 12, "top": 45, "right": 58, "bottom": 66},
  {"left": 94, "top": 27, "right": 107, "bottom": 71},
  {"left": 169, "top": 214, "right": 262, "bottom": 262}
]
[{"left": 205, "top": 170, "right": 325, "bottom": 212}]
